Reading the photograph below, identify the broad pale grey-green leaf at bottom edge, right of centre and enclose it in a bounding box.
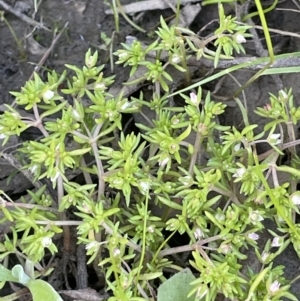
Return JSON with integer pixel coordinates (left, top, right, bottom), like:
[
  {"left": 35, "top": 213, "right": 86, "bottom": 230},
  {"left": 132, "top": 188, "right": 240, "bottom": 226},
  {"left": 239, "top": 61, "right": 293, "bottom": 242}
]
[{"left": 157, "top": 269, "right": 196, "bottom": 301}]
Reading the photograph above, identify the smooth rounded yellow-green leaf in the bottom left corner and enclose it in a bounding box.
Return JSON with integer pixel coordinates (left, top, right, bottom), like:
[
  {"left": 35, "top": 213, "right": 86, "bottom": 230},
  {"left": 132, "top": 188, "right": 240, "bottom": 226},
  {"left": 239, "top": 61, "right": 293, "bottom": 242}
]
[{"left": 27, "top": 279, "right": 63, "bottom": 301}]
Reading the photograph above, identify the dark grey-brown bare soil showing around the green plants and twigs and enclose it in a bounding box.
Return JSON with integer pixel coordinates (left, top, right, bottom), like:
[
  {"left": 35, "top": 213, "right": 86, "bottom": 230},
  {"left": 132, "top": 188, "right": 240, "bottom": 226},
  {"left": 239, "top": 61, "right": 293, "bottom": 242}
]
[{"left": 0, "top": 0, "right": 300, "bottom": 298}]
